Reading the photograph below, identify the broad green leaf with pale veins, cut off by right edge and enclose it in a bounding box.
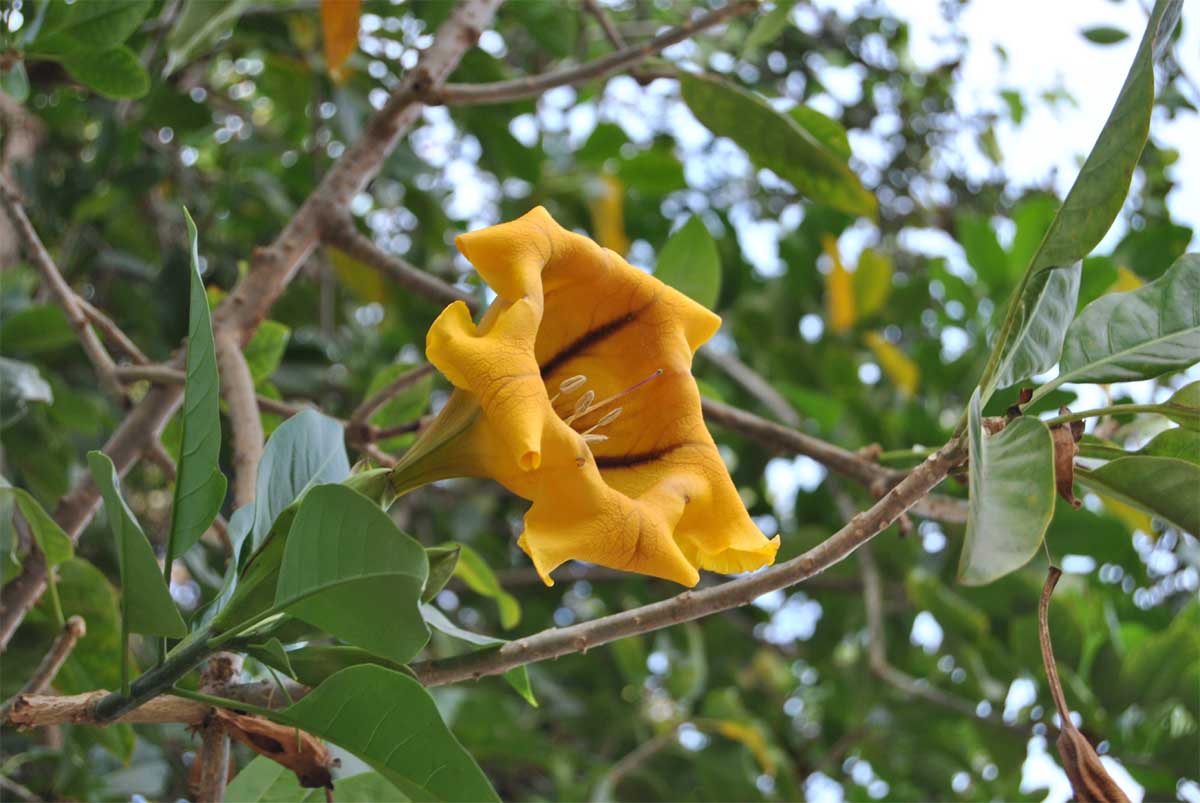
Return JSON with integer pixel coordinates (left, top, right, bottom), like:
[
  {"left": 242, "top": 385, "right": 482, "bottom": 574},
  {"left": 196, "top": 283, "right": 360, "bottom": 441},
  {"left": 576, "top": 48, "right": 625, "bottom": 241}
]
[{"left": 1054, "top": 253, "right": 1200, "bottom": 385}]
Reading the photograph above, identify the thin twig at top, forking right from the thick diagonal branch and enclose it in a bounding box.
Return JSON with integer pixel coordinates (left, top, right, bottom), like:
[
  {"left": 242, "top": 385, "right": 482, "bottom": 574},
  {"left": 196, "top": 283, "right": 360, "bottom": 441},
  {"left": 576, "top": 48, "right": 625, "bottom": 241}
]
[{"left": 421, "top": 1, "right": 758, "bottom": 106}]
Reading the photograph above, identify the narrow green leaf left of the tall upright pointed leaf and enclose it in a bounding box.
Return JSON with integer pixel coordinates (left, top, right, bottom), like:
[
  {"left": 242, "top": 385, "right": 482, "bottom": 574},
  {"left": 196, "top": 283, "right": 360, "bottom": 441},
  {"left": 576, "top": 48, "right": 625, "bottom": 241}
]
[{"left": 88, "top": 451, "right": 187, "bottom": 639}]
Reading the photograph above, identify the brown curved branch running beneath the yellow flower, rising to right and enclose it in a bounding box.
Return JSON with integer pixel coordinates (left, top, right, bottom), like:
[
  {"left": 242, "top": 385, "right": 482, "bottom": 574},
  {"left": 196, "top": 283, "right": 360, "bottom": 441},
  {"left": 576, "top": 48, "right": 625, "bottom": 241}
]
[{"left": 412, "top": 434, "right": 965, "bottom": 685}]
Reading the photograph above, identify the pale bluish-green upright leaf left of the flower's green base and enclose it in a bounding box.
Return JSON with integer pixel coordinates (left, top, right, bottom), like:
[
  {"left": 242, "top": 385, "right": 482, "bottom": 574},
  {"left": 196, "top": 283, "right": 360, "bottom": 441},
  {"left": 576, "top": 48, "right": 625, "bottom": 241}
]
[{"left": 250, "top": 409, "right": 350, "bottom": 550}]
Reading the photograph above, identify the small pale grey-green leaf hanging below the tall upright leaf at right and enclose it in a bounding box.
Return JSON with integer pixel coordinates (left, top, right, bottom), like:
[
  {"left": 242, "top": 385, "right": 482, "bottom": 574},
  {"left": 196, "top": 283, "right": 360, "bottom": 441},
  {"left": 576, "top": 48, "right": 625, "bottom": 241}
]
[{"left": 983, "top": 262, "right": 1080, "bottom": 391}]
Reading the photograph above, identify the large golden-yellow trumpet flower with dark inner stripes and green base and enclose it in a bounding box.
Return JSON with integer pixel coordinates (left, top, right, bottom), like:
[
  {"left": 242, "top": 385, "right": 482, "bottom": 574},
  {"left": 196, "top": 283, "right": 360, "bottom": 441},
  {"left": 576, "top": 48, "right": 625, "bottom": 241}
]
[{"left": 392, "top": 206, "right": 779, "bottom": 586}]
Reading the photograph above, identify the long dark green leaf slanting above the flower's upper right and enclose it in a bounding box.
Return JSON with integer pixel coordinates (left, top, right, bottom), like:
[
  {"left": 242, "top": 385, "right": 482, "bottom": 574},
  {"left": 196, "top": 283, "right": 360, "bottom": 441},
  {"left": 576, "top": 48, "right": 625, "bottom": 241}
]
[{"left": 680, "top": 74, "right": 877, "bottom": 220}]
